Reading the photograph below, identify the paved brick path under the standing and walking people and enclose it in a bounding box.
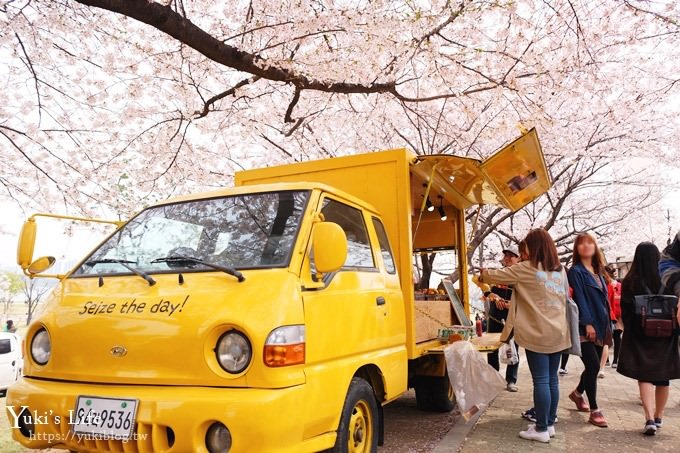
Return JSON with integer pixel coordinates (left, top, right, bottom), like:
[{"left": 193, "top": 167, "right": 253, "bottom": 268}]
[{"left": 444, "top": 355, "right": 680, "bottom": 453}]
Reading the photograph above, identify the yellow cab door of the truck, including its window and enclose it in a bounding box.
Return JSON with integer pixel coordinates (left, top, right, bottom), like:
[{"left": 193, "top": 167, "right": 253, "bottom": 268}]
[{"left": 302, "top": 195, "right": 394, "bottom": 429}]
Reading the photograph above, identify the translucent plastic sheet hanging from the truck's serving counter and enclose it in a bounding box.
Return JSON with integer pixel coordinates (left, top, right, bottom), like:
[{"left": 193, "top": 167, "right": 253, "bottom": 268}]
[{"left": 444, "top": 341, "right": 506, "bottom": 421}]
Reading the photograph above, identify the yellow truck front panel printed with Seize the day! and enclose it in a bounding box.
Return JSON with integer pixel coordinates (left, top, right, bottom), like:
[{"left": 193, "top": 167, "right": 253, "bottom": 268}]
[{"left": 25, "top": 269, "right": 304, "bottom": 388}]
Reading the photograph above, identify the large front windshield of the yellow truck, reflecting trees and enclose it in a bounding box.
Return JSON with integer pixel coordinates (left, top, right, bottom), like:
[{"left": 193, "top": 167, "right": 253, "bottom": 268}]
[{"left": 72, "top": 191, "right": 309, "bottom": 276}]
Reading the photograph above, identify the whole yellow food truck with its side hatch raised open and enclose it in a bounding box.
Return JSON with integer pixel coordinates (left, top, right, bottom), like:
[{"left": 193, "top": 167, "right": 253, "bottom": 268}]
[{"left": 7, "top": 130, "right": 550, "bottom": 453}]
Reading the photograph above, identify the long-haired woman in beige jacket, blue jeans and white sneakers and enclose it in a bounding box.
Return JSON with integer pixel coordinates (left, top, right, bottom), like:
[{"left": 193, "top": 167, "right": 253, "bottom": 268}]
[{"left": 481, "top": 229, "right": 571, "bottom": 442}]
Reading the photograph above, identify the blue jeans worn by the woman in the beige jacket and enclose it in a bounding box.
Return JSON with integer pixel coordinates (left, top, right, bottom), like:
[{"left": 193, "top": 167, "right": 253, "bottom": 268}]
[{"left": 526, "top": 350, "right": 562, "bottom": 432}]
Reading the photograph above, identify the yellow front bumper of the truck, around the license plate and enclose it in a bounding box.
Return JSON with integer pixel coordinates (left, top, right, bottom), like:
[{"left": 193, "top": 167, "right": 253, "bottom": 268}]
[{"left": 7, "top": 378, "right": 335, "bottom": 453}]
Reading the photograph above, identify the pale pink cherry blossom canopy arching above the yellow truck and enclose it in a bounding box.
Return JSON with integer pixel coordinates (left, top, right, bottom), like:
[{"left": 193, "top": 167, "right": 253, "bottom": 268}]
[{"left": 0, "top": 0, "right": 680, "bottom": 258}]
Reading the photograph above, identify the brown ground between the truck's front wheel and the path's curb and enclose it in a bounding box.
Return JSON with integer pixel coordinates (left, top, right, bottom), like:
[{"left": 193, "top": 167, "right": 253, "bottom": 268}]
[{"left": 378, "top": 390, "right": 456, "bottom": 453}]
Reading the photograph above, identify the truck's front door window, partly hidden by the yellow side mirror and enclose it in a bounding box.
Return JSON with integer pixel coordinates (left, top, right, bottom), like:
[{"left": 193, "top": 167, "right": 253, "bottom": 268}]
[{"left": 321, "top": 199, "right": 375, "bottom": 268}]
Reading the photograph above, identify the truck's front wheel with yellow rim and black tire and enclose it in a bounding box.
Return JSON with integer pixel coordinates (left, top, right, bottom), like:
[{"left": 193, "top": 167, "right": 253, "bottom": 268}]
[{"left": 330, "top": 377, "right": 378, "bottom": 453}]
